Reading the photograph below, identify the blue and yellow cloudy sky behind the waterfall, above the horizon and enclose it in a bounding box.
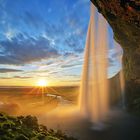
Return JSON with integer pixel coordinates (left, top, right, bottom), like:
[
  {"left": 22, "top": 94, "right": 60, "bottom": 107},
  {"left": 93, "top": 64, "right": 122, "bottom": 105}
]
[{"left": 0, "top": 0, "right": 122, "bottom": 86}]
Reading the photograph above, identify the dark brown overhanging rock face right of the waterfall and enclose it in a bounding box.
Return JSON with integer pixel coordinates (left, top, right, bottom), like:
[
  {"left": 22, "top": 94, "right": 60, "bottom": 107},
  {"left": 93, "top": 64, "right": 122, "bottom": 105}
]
[{"left": 91, "top": 0, "right": 140, "bottom": 112}]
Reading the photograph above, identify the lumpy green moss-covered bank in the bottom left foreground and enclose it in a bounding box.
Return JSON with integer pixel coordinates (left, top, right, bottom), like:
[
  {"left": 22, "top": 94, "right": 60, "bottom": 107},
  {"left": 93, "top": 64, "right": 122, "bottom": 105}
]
[{"left": 0, "top": 113, "right": 76, "bottom": 140}]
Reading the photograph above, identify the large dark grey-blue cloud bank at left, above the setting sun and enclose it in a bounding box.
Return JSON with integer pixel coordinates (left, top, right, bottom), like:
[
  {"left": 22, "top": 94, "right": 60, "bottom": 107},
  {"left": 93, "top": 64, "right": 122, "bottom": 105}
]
[{"left": 0, "top": 35, "right": 58, "bottom": 65}]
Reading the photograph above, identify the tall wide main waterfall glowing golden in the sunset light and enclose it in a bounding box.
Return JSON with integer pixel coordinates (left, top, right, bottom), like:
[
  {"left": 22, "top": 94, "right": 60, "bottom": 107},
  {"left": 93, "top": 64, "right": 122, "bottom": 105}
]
[{"left": 79, "top": 4, "right": 109, "bottom": 123}]
